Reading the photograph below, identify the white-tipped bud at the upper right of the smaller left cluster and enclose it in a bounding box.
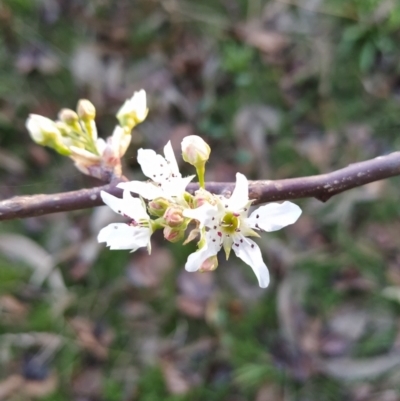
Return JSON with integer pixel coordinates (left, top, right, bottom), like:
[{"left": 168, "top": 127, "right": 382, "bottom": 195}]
[{"left": 117, "top": 89, "right": 148, "bottom": 131}]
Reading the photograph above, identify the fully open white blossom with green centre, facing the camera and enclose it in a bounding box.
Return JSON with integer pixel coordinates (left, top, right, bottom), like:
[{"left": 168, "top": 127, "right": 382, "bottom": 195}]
[{"left": 183, "top": 173, "right": 301, "bottom": 288}]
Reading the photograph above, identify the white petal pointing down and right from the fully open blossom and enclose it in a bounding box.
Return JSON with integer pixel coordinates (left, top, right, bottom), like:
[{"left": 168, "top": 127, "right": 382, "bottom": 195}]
[{"left": 232, "top": 235, "right": 269, "bottom": 288}]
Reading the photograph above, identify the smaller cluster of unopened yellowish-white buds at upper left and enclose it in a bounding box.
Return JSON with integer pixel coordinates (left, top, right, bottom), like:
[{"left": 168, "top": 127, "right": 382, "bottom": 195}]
[{"left": 26, "top": 90, "right": 148, "bottom": 181}]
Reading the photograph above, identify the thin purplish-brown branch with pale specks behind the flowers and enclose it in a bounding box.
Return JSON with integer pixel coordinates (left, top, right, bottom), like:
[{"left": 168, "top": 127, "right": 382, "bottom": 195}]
[{"left": 0, "top": 152, "right": 400, "bottom": 221}]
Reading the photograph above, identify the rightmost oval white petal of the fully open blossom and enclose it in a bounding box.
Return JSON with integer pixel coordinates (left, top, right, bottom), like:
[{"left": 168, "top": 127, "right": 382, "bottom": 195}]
[{"left": 247, "top": 201, "right": 301, "bottom": 231}]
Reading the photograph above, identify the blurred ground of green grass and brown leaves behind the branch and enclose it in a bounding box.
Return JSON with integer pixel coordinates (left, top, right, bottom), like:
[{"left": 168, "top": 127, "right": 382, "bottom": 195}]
[{"left": 0, "top": 0, "right": 400, "bottom": 401}]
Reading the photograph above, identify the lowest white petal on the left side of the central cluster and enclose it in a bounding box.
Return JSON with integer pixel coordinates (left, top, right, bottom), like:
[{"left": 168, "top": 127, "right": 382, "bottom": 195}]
[{"left": 97, "top": 223, "right": 151, "bottom": 252}]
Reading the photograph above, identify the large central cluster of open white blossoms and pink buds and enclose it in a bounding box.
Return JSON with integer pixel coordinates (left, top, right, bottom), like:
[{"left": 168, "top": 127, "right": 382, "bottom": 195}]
[{"left": 98, "top": 135, "right": 301, "bottom": 288}]
